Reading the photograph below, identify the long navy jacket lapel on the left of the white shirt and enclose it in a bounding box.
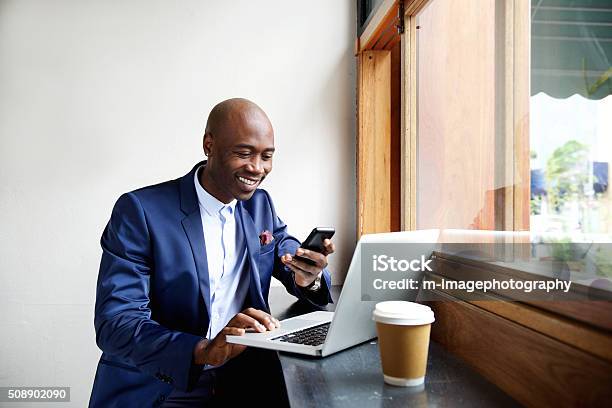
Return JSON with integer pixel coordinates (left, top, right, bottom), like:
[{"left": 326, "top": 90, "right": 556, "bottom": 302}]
[{"left": 180, "top": 162, "right": 210, "bottom": 321}]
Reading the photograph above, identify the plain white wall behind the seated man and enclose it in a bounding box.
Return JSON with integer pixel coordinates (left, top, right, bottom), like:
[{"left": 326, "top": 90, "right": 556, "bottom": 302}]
[{"left": 0, "top": 0, "right": 355, "bottom": 406}]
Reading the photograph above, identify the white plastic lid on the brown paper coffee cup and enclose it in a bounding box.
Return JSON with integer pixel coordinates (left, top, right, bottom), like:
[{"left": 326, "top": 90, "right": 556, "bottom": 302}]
[{"left": 372, "top": 300, "right": 435, "bottom": 326}]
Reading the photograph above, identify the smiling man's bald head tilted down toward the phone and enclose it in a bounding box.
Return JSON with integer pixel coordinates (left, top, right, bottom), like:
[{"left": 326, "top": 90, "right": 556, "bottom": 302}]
[{"left": 200, "top": 99, "right": 274, "bottom": 203}]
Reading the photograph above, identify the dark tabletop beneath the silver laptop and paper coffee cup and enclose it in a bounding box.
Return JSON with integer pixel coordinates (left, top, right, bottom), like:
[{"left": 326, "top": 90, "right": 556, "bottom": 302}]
[{"left": 270, "top": 287, "right": 520, "bottom": 408}]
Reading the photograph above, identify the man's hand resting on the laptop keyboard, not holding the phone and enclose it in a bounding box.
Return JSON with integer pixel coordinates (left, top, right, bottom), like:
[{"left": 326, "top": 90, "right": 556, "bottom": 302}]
[{"left": 193, "top": 307, "right": 280, "bottom": 366}]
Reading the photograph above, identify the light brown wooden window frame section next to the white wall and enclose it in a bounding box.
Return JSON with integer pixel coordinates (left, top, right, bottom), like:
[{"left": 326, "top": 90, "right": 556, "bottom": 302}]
[{"left": 355, "top": 0, "right": 404, "bottom": 238}]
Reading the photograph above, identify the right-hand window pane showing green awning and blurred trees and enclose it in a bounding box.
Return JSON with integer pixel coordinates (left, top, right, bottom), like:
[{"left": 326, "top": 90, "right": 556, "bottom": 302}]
[{"left": 530, "top": 0, "right": 612, "bottom": 236}]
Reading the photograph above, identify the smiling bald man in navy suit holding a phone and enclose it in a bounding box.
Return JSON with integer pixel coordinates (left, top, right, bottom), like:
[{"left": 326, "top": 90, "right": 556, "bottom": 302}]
[{"left": 90, "top": 99, "right": 334, "bottom": 407}]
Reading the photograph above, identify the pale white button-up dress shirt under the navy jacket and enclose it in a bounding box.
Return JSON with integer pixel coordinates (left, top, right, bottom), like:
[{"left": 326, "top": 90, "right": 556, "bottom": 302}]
[{"left": 193, "top": 166, "right": 249, "bottom": 340}]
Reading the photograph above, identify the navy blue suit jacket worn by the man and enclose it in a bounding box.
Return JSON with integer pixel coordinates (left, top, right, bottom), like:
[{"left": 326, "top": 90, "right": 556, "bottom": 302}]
[{"left": 89, "top": 163, "right": 331, "bottom": 407}]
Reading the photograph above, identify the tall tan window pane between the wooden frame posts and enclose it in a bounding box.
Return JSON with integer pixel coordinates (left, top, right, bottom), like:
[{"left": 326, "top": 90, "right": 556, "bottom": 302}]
[{"left": 416, "top": 0, "right": 505, "bottom": 229}]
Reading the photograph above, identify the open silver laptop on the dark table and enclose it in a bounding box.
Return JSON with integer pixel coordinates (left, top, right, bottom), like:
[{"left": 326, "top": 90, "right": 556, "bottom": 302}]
[{"left": 227, "top": 231, "right": 437, "bottom": 357}]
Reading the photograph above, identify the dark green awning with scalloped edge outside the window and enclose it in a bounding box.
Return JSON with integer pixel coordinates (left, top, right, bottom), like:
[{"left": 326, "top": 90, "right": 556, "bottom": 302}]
[{"left": 531, "top": 0, "right": 612, "bottom": 99}]
